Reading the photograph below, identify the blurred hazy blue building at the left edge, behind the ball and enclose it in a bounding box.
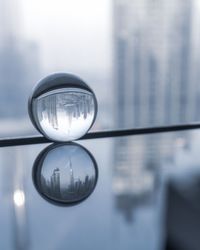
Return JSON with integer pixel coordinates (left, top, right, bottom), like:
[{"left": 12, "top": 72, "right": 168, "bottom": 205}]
[{"left": 0, "top": 0, "right": 39, "bottom": 119}]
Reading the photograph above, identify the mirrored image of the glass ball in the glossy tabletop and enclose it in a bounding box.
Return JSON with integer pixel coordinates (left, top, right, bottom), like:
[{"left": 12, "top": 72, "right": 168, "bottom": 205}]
[{"left": 33, "top": 143, "right": 98, "bottom": 205}]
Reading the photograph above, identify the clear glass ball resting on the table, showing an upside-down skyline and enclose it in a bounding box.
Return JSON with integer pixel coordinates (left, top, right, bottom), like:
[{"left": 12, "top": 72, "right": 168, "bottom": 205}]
[{"left": 29, "top": 73, "right": 97, "bottom": 141}]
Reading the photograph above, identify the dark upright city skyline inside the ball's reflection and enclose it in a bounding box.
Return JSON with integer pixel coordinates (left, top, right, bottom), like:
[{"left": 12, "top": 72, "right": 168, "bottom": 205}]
[{"left": 41, "top": 159, "right": 95, "bottom": 200}]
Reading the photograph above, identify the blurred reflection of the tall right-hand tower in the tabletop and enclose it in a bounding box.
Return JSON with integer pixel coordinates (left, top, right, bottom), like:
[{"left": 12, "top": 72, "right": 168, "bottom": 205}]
[{"left": 112, "top": 138, "right": 160, "bottom": 223}]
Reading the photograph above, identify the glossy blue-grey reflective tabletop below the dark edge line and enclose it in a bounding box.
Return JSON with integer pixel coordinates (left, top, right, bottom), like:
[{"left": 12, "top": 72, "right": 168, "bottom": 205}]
[{"left": 0, "top": 130, "right": 200, "bottom": 250}]
